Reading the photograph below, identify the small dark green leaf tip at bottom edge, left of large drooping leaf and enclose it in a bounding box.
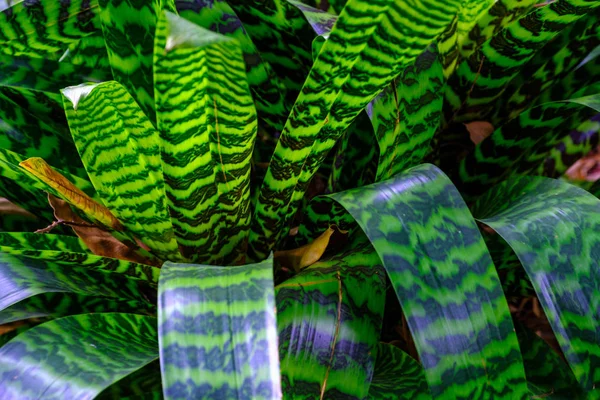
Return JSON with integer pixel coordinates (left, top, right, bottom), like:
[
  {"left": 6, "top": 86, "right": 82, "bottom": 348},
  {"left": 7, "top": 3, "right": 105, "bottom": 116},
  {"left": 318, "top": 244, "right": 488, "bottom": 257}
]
[{"left": 368, "top": 343, "right": 431, "bottom": 400}]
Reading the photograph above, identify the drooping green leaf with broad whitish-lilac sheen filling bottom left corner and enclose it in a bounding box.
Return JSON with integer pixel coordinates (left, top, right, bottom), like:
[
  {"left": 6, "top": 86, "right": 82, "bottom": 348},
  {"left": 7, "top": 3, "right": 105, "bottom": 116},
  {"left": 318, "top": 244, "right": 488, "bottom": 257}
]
[{"left": 0, "top": 313, "right": 158, "bottom": 400}]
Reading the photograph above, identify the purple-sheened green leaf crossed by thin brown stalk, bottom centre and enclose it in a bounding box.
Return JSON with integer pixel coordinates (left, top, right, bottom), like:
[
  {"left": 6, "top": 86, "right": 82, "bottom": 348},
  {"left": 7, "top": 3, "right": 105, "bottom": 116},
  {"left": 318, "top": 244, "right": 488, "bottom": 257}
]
[{"left": 275, "top": 234, "right": 385, "bottom": 399}]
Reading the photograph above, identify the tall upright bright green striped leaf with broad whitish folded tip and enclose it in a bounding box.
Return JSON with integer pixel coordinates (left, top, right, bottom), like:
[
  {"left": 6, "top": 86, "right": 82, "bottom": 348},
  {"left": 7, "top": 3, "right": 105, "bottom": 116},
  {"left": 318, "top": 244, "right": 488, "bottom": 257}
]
[{"left": 154, "top": 12, "right": 257, "bottom": 265}]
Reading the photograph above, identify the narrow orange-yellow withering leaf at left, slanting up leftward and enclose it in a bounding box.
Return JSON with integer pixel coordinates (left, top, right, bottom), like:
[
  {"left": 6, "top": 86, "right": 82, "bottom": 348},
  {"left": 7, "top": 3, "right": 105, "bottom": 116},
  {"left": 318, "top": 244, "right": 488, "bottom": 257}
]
[{"left": 19, "top": 157, "right": 123, "bottom": 231}]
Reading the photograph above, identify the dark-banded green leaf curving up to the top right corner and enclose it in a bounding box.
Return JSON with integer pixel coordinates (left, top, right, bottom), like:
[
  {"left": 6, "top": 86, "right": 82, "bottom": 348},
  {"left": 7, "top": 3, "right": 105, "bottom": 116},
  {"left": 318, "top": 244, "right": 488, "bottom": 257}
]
[{"left": 446, "top": 0, "right": 600, "bottom": 122}]
